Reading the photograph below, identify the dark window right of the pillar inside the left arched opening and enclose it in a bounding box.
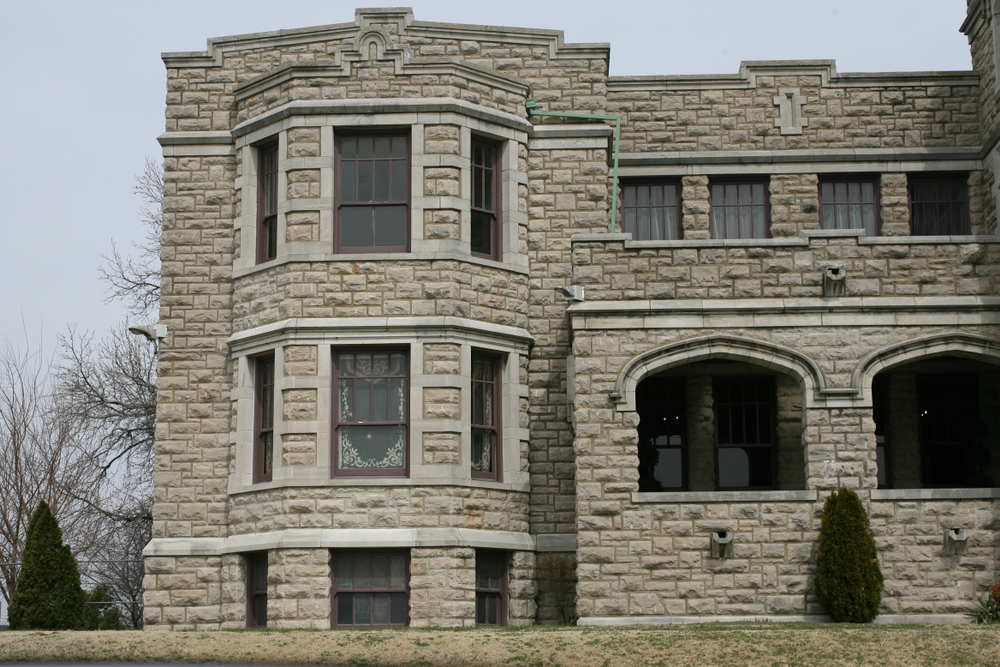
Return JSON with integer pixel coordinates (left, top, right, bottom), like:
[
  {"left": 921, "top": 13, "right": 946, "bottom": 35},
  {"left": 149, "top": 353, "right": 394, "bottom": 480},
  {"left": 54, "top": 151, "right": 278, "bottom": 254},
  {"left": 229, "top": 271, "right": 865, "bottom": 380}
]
[{"left": 712, "top": 376, "right": 776, "bottom": 489}]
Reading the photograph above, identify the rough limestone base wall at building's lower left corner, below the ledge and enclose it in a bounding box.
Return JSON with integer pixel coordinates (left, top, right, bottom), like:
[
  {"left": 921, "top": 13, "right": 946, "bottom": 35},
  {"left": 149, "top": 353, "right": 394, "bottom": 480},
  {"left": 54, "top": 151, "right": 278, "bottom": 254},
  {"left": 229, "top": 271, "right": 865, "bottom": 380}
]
[{"left": 143, "top": 556, "right": 224, "bottom": 630}]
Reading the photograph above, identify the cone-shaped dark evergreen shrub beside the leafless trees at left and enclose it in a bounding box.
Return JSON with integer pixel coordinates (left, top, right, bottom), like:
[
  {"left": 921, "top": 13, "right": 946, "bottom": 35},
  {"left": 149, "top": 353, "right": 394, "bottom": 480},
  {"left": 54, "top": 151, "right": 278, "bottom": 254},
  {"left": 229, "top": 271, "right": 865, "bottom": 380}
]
[{"left": 7, "top": 501, "right": 86, "bottom": 630}]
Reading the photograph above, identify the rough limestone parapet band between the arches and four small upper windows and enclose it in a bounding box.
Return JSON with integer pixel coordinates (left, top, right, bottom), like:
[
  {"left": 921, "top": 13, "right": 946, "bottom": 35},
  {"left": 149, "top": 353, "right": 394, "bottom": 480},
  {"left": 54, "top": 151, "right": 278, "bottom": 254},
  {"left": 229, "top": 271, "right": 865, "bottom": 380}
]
[{"left": 573, "top": 236, "right": 1000, "bottom": 301}]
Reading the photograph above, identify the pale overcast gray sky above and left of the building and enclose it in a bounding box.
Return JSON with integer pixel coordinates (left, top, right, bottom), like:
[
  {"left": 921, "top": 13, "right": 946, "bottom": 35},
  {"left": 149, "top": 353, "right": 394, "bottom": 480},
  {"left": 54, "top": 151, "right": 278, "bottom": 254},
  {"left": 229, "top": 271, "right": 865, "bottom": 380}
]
[{"left": 0, "top": 0, "right": 971, "bottom": 352}]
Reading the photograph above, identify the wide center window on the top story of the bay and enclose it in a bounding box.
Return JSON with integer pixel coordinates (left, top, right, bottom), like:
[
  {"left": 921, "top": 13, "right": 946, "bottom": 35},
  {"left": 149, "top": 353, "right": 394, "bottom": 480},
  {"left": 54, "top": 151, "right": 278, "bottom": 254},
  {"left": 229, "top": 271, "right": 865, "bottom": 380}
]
[{"left": 335, "top": 134, "right": 410, "bottom": 252}]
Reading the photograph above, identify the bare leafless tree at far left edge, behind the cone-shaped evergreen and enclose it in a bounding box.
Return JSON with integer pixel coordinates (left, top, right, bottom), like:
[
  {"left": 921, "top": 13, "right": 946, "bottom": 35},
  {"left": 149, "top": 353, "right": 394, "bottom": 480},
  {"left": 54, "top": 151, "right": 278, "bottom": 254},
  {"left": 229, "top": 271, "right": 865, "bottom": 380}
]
[{"left": 0, "top": 340, "right": 108, "bottom": 616}]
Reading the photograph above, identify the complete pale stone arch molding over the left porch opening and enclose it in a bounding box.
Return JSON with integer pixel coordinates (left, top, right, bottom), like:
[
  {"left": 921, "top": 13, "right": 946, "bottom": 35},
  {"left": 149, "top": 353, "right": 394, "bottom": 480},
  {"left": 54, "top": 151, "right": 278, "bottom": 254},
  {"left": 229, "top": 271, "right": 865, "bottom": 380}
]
[{"left": 611, "top": 336, "right": 825, "bottom": 412}]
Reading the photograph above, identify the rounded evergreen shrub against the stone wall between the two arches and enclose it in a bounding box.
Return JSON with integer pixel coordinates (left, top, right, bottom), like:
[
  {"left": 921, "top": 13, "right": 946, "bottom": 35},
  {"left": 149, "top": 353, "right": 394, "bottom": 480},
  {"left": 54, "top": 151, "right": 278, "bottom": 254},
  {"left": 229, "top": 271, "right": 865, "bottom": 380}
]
[{"left": 816, "top": 487, "right": 882, "bottom": 623}]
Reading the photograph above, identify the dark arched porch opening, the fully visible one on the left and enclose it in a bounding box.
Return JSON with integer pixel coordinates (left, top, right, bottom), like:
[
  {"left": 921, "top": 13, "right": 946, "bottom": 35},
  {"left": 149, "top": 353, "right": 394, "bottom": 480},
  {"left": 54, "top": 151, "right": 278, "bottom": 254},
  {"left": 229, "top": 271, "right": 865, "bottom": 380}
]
[{"left": 635, "top": 360, "right": 805, "bottom": 492}]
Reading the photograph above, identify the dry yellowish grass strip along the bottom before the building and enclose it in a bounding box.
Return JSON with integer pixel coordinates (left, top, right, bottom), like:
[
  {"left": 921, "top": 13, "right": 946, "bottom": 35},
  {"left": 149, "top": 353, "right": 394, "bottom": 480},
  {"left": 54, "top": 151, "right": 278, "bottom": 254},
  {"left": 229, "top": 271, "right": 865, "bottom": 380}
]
[{"left": 0, "top": 623, "right": 1000, "bottom": 667}]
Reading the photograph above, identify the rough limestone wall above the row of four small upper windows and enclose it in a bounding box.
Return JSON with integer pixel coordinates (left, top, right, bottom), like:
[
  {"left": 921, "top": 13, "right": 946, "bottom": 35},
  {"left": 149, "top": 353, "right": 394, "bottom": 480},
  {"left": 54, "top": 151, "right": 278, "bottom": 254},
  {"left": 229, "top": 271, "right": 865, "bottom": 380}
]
[{"left": 608, "top": 75, "right": 980, "bottom": 153}]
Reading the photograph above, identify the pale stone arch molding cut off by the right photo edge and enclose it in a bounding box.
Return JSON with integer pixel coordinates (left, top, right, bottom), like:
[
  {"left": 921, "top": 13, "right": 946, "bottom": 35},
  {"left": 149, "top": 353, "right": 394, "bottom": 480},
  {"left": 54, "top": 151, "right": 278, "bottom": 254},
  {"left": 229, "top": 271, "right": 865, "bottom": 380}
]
[{"left": 851, "top": 331, "right": 1000, "bottom": 404}]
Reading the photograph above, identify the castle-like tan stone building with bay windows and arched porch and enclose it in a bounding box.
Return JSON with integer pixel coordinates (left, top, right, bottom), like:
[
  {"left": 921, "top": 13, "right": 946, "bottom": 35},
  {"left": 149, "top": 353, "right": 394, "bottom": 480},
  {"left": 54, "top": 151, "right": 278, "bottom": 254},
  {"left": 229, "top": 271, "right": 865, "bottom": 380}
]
[{"left": 145, "top": 0, "right": 1000, "bottom": 629}]
